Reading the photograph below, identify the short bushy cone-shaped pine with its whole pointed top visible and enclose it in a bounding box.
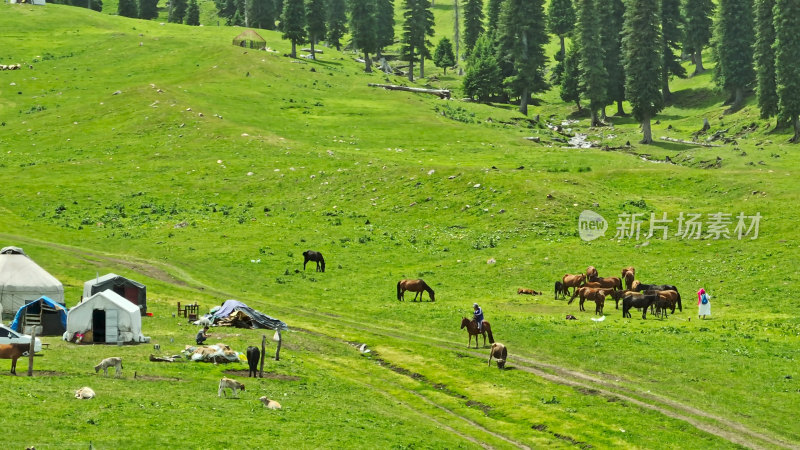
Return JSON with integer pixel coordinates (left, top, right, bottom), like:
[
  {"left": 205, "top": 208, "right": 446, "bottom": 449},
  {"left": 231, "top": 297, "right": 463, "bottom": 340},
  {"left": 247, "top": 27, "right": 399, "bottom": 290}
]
[{"left": 463, "top": 33, "right": 503, "bottom": 102}]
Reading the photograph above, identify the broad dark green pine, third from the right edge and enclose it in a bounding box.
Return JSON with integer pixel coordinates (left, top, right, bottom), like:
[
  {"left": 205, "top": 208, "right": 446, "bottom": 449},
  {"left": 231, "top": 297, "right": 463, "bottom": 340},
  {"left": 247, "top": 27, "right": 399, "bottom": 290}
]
[{"left": 713, "top": 0, "right": 755, "bottom": 112}]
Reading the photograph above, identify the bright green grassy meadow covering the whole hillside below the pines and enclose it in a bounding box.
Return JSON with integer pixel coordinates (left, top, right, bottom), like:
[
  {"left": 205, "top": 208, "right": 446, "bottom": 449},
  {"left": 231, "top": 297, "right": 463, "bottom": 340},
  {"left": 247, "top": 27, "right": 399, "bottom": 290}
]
[{"left": 0, "top": 4, "right": 800, "bottom": 449}]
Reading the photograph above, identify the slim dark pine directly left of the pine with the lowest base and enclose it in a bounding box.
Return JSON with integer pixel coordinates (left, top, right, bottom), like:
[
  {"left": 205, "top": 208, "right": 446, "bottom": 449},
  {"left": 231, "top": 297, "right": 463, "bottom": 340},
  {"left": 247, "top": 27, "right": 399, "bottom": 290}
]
[{"left": 599, "top": 0, "right": 625, "bottom": 116}]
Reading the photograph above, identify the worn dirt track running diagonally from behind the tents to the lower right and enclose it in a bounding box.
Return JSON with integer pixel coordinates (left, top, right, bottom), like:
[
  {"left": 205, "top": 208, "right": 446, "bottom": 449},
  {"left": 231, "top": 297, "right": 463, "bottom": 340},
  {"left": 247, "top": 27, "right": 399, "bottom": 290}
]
[{"left": 17, "top": 233, "right": 798, "bottom": 448}]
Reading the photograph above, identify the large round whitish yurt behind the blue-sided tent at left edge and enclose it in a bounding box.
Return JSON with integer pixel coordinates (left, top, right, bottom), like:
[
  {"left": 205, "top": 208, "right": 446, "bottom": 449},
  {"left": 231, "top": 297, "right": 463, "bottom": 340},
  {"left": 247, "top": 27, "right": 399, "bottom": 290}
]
[{"left": 0, "top": 247, "right": 64, "bottom": 320}]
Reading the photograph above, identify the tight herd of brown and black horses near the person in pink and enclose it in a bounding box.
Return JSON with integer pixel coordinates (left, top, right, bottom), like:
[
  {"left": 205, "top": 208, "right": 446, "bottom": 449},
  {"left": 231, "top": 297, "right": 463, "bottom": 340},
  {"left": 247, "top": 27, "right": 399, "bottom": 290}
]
[{"left": 555, "top": 266, "right": 683, "bottom": 319}]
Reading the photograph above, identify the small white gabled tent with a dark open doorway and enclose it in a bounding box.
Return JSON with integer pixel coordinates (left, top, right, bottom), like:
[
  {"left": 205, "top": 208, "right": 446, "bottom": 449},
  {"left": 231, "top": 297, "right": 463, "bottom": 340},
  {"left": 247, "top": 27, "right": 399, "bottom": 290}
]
[{"left": 64, "top": 290, "right": 150, "bottom": 344}]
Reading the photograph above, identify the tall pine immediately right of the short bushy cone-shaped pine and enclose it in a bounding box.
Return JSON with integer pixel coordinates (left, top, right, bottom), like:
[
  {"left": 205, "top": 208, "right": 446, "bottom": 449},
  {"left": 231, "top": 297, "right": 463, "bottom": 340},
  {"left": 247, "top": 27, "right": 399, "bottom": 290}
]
[{"left": 497, "top": 0, "right": 548, "bottom": 114}]
